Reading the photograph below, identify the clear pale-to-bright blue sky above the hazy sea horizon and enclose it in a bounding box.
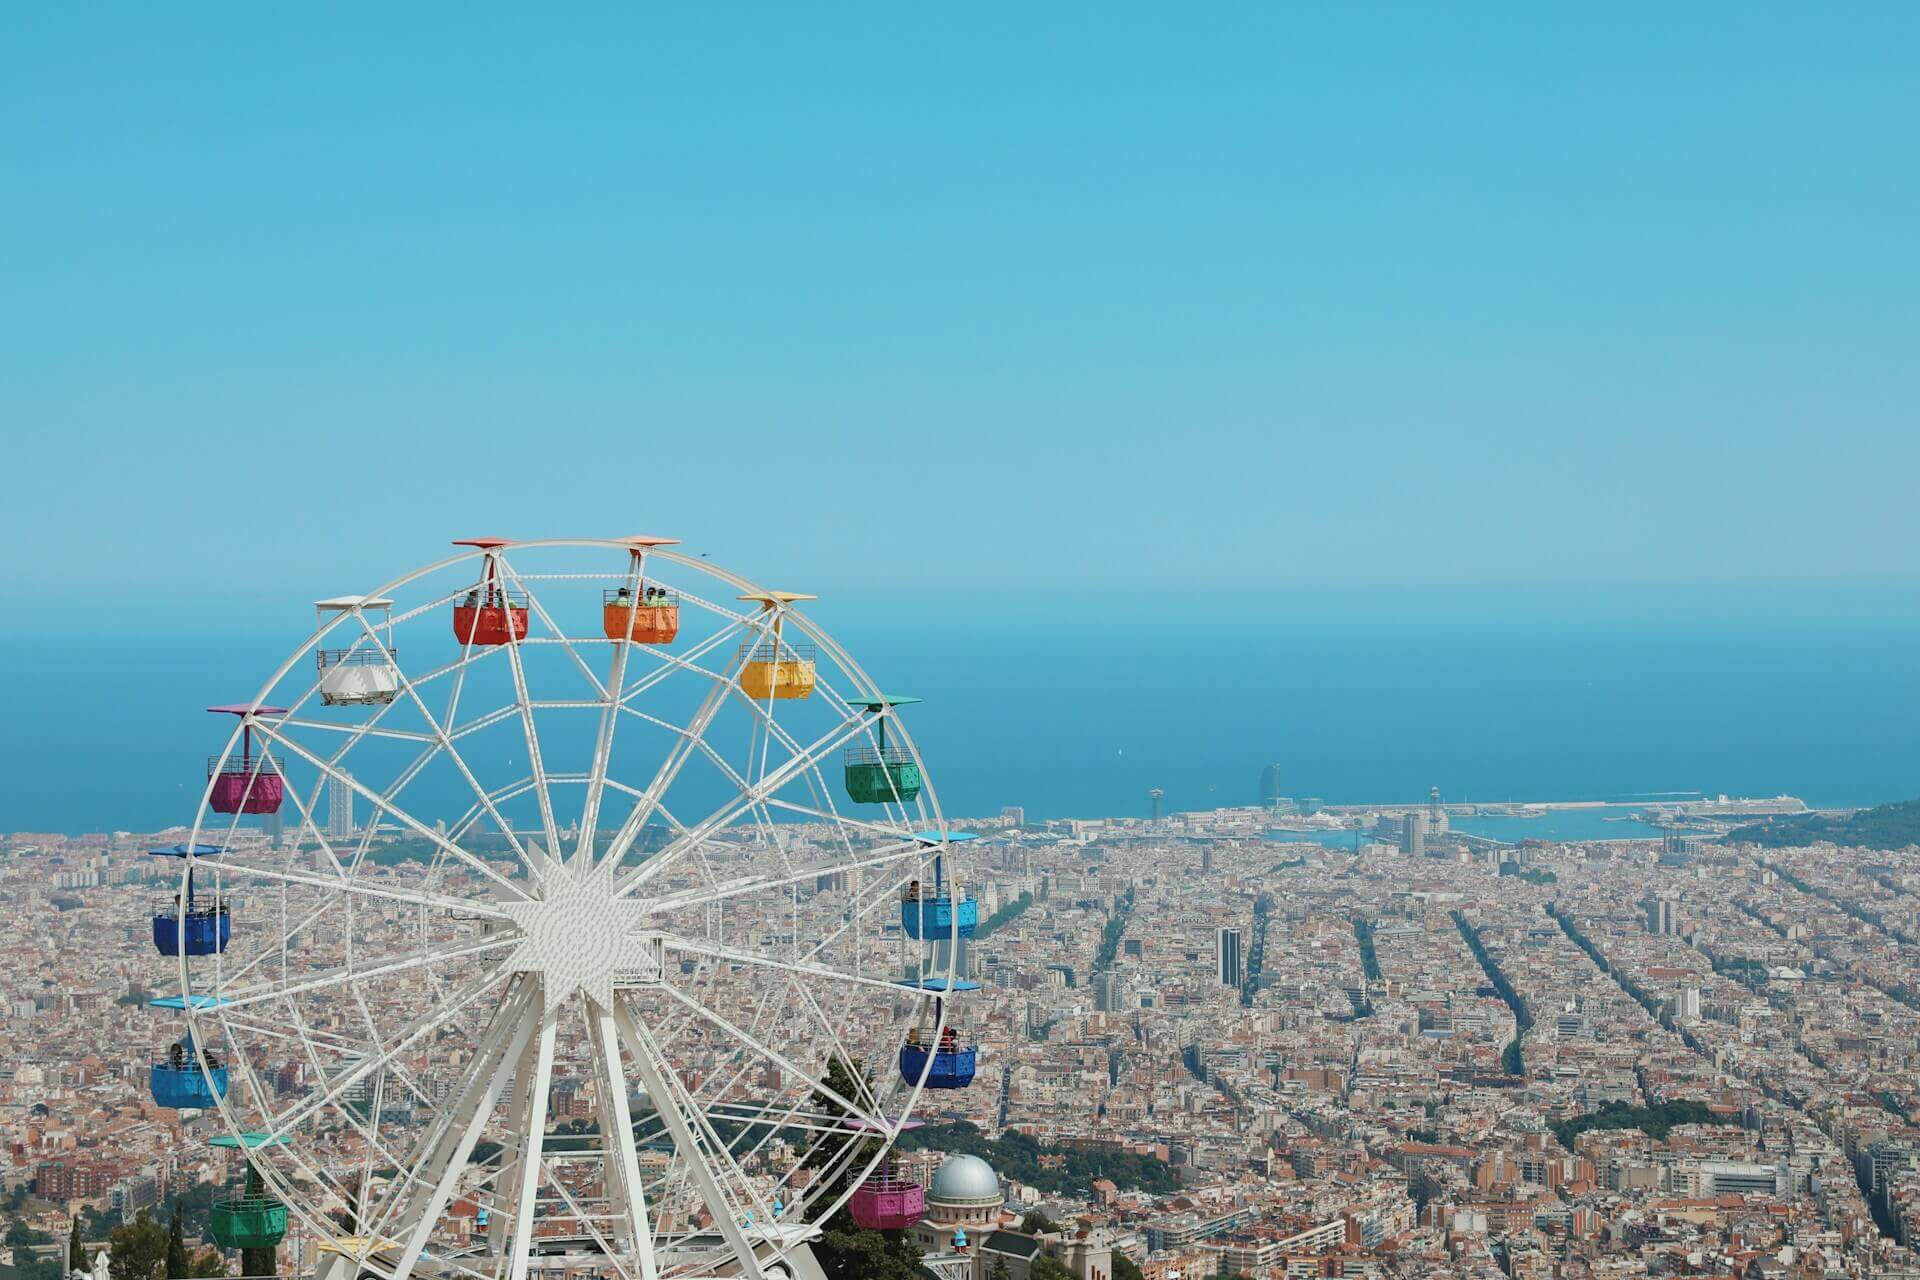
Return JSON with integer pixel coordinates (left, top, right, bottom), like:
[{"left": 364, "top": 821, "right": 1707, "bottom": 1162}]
[{"left": 0, "top": 4, "right": 1920, "bottom": 610}]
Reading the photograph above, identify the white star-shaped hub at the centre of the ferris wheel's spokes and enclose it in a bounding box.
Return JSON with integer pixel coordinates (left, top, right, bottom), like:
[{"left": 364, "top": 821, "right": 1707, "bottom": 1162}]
[{"left": 501, "top": 864, "right": 659, "bottom": 1007}]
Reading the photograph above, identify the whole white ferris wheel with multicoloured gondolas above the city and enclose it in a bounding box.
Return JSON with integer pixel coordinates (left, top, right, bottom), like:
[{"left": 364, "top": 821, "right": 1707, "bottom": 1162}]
[{"left": 152, "top": 537, "right": 979, "bottom": 1280}]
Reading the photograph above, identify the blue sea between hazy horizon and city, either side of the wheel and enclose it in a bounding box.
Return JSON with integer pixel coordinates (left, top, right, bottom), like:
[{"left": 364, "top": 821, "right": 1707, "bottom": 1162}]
[{"left": 0, "top": 601, "right": 1920, "bottom": 839}]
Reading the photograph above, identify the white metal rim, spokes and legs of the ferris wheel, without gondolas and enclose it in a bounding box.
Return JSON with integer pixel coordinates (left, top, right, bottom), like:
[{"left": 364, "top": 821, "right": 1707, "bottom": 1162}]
[{"left": 157, "top": 539, "right": 962, "bottom": 1280}]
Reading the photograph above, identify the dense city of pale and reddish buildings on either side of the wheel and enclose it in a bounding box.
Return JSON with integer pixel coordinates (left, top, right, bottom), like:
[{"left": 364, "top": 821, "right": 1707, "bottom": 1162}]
[{"left": 11, "top": 779, "right": 1920, "bottom": 1280}]
